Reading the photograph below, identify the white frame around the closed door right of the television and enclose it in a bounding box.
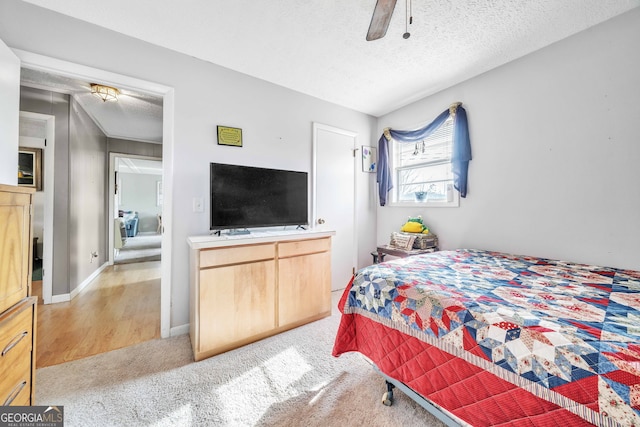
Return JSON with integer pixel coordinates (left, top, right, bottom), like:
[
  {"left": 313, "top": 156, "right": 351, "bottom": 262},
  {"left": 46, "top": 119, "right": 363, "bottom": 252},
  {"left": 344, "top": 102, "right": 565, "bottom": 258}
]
[{"left": 311, "top": 122, "right": 358, "bottom": 285}]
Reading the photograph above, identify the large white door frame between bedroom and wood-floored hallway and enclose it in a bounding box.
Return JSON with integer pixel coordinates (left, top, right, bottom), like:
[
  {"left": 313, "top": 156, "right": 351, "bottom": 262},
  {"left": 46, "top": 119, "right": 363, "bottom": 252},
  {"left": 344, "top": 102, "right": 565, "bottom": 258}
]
[{"left": 12, "top": 49, "right": 175, "bottom": 338}]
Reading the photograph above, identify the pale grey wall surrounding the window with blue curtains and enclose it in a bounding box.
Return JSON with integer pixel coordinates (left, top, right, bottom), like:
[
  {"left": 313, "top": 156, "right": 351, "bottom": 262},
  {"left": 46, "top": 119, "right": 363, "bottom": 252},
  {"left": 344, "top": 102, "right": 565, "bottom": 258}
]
[{"left": 377, "top": 9, "right": 640, "bottom": 270}]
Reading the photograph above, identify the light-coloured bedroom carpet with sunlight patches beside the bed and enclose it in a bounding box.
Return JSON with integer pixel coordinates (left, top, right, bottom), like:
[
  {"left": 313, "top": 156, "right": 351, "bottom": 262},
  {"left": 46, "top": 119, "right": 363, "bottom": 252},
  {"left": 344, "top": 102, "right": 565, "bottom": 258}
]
[{"left": 36, "top": 292, "right": 442, "bottom": 427}]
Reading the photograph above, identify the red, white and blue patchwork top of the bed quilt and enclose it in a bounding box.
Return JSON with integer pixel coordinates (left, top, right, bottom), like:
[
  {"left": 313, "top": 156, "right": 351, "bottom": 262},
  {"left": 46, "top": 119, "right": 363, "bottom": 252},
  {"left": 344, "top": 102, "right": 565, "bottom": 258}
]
[{"left": 334, "top": 250, "right": 640, "bottom": 426}]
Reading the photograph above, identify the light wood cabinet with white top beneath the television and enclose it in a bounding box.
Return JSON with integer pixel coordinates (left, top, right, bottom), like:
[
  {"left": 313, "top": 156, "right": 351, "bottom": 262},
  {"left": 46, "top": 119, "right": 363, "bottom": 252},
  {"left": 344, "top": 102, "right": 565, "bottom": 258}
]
[{"left": 189, "top": 232, "right": 333, "bottom": 360}]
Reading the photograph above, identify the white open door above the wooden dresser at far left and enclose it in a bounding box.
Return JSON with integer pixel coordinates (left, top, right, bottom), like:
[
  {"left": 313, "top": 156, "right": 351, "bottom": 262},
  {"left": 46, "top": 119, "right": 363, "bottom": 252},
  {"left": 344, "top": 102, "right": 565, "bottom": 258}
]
[{"left": 0, "top": 40, "right": 20, "bottom": 185}]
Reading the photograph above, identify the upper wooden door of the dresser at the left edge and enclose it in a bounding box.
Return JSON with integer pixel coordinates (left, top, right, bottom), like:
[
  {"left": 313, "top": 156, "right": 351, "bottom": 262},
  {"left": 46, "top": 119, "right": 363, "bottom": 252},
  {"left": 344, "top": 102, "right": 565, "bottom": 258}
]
[{"left": 0, "top": 191, "right": 31, "bottom": 314}]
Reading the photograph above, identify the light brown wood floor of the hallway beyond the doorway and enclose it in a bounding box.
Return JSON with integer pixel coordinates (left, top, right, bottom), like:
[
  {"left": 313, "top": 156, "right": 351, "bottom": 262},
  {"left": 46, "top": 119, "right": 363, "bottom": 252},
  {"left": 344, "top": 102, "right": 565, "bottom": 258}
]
[{"left": 33, "top": 261, "right": 160, "bottom": 368}]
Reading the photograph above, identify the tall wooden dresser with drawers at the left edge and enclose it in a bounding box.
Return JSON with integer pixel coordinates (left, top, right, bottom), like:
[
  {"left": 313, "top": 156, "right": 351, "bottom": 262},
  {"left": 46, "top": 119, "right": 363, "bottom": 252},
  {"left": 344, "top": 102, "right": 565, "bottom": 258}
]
[{"left": 0, "top": 184, "right": 38, "bottom": 406}]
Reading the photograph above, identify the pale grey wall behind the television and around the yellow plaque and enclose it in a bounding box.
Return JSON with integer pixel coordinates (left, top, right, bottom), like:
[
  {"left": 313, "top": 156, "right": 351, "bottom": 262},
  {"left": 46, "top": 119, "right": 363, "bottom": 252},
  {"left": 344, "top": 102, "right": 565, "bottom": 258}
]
[{"left": 0, "top": 0, "right": 376, "bottom": 327}]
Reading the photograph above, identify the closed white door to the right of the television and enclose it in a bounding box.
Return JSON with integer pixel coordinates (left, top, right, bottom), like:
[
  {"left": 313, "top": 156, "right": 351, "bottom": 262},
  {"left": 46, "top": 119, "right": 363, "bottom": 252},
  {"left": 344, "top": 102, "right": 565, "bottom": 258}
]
[{"left": 312, "top": 123, "right": 357, "bottom": 290}]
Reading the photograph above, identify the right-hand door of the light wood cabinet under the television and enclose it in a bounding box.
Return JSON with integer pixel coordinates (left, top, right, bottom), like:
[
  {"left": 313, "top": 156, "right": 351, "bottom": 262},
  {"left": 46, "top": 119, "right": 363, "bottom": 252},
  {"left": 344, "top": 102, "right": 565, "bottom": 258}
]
[{"left": 278, "top": 252, "right": 331, "bottom": 326}]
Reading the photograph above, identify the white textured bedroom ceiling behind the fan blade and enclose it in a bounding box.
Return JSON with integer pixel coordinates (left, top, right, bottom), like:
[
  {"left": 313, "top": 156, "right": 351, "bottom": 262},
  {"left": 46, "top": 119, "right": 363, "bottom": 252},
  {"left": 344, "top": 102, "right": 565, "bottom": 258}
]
[{"left": 17, "top": 0, "right": 640, "bottom": 141}]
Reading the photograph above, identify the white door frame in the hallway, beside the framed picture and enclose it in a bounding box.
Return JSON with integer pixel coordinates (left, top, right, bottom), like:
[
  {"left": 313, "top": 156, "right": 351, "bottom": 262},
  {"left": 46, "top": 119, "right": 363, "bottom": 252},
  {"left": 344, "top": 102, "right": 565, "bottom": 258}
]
[{"left": 20, "top": 111, "right": 56, "bottom": 304}]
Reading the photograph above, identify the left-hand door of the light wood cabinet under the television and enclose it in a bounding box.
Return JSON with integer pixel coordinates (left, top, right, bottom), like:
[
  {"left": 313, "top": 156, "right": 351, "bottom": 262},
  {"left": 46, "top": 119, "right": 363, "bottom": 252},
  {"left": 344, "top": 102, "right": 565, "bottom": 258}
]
[{"left": 198, "top": 260, "right": 275, "bottom": 352}]
